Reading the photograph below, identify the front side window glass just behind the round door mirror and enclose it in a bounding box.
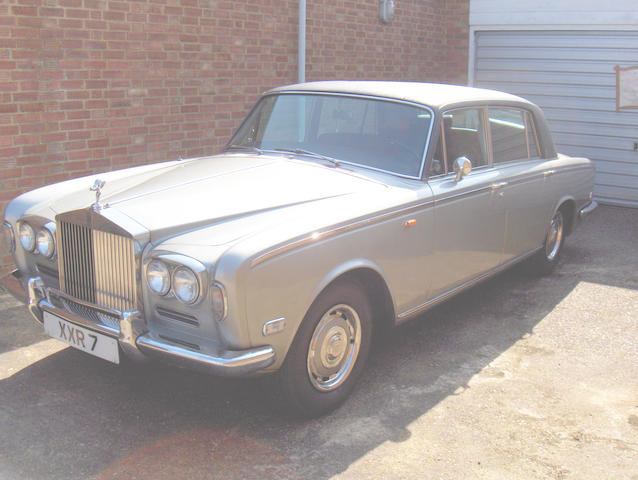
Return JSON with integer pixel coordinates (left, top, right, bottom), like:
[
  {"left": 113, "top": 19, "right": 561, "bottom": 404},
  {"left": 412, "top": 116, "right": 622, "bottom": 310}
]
[{"left": 443, "top": 108, "right": 487, "bottom": 172}]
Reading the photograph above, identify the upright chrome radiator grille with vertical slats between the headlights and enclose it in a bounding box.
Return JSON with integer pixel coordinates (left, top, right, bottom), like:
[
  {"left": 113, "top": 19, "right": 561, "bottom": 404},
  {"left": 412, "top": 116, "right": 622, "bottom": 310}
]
[{"left": 57, "top": 219, "right": 137, "bottom": 311}]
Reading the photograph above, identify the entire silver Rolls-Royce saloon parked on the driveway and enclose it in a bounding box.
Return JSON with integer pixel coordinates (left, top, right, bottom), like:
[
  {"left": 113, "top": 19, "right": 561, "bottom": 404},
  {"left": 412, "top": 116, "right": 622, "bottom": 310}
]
[{"left": 2, "top": 82, "right": 596, "bottom": 415}]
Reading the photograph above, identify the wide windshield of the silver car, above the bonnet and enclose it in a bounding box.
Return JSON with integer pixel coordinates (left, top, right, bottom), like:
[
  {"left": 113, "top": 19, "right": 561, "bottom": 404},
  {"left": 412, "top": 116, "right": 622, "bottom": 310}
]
[{"left": 229, "top": 94, "right": 432, "bottom": 178}]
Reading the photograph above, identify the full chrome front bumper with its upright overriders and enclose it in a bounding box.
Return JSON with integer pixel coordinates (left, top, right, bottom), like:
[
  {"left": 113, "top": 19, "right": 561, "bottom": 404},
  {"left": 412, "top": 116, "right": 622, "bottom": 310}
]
[{"left": 0, "top": 268, "right": 275, "bottom": 377}]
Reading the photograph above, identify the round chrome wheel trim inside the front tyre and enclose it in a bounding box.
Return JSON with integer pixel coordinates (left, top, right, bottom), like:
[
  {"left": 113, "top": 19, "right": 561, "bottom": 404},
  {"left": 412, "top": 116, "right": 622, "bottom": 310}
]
[{"left": 307, "top": 304, "right": 361, "bottom": 392}]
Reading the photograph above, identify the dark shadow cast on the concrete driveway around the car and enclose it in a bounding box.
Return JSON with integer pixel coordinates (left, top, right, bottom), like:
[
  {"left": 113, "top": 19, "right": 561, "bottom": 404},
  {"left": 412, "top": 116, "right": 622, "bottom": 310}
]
[{"left": 0, "top": 207, "right": 638, "bottom": 480}]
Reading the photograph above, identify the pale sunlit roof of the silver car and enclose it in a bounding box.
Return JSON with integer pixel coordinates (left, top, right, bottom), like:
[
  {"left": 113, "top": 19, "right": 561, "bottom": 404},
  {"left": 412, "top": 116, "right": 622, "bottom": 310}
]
[{"left": 266, "top": 81, "right": 529, "bottom": 108}]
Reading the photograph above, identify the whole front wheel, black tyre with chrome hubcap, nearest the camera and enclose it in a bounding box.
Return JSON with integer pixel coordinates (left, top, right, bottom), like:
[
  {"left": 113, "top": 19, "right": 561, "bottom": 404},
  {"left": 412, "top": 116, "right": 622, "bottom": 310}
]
[{"left": 278, "top": 281, "right": 372, "bottom": 418}]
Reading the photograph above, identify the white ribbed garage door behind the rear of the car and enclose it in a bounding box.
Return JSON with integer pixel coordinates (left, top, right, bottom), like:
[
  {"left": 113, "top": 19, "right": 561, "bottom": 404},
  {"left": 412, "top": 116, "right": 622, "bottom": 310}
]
[{"left": 474, "top": 31, "right": 638, "bottom": 207}]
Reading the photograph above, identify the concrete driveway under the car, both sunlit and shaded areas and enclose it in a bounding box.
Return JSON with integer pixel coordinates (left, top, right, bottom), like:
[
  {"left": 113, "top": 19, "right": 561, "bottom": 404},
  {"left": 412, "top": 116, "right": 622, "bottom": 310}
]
[{"left": 0, "top": 207, "right": 638, "bottom": 480}]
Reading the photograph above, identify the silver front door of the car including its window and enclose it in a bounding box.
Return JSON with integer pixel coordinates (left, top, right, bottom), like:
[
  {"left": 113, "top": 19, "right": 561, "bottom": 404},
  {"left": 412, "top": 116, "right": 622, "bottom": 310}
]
[{"left": 429, "top": 108, "right": 505, "bottom": 299}]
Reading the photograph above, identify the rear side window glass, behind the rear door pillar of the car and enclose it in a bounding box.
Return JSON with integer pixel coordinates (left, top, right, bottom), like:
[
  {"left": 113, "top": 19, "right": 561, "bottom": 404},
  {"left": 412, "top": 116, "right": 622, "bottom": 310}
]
[{"left": 488, "top": 108, "right": 538, "bottom": 164}]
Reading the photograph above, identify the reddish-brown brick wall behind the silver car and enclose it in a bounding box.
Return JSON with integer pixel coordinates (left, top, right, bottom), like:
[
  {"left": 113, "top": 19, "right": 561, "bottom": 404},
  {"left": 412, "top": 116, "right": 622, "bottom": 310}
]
[{"left": 0, "top": 0, "right": 469, "bottom": 265}]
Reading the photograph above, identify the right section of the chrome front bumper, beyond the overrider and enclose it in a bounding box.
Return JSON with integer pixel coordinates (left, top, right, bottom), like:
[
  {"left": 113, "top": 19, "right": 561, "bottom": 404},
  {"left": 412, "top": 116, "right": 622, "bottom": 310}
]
[{"left": 137, "top": 334, "right": 275, "bottom": 377}]
